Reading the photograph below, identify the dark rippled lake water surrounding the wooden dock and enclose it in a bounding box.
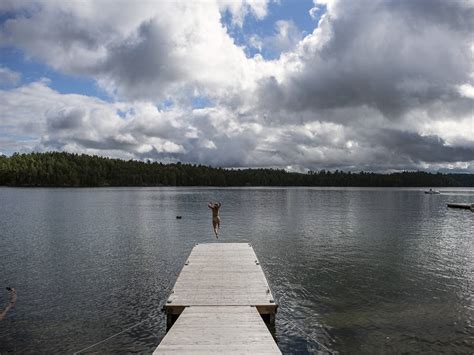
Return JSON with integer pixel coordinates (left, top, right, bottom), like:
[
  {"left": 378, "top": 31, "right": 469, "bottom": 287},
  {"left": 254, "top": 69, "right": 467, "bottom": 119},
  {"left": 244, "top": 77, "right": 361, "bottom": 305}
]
[{"left": 0, "top": 188, "right": 474, "bottom": 354}]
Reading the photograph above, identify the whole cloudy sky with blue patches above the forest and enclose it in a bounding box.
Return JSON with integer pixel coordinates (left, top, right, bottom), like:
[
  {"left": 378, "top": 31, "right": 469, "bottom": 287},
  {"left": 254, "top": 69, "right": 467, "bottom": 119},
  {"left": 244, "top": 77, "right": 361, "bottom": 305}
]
[{"left": 0, "top": 0, "right": 474, "bottom": 173}]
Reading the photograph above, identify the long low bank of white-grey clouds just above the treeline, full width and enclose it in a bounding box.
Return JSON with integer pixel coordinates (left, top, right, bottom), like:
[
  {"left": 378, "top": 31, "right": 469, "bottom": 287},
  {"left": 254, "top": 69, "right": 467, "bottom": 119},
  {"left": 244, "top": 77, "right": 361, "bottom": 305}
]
[{"left": 0, "top": 82, "right": 474, "bottom": 170}]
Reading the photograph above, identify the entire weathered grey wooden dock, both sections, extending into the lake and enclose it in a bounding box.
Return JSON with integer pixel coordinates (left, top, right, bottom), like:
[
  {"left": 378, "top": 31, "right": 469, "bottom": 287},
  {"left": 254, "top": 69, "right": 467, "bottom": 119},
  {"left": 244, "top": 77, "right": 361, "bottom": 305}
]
[{"left": 154, "top": 243, "right": 281, "bottom": 354}]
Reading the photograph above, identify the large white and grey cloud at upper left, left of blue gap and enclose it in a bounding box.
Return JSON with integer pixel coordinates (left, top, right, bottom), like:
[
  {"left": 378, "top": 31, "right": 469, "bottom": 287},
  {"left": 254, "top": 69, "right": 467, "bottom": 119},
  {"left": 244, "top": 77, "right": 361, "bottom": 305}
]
[{"left": 2, "top": 0, "right": 267, "bottom": 100}]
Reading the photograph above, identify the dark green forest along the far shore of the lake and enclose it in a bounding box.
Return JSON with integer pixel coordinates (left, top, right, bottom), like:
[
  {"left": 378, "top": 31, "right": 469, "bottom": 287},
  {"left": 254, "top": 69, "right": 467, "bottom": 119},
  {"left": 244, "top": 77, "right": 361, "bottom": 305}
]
[{"left": 0, "top": 152, "right": 474, "bottom": 187}]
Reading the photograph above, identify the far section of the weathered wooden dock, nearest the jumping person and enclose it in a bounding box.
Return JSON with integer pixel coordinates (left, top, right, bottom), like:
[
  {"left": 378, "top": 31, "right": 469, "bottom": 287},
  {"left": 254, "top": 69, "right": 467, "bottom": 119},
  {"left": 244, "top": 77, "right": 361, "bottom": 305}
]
[{"left": 166, "top": 243, "right": 276, "bottom": 313}]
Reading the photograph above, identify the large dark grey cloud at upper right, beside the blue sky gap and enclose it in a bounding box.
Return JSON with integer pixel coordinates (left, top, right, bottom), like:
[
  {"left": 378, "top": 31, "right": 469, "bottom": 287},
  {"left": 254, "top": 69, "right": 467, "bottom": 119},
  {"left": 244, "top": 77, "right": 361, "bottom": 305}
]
[{"left": 259, "top": 0, "right": 474, "bottom": 119}]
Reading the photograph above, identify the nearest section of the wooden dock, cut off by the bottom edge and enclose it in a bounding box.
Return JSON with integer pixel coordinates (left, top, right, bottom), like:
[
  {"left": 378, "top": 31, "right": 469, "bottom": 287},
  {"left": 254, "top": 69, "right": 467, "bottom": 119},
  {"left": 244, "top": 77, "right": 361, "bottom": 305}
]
[{"left": 153, "top": 306, "right": 281, "bottom": 355}]
